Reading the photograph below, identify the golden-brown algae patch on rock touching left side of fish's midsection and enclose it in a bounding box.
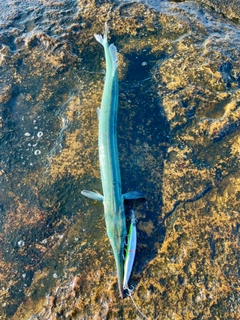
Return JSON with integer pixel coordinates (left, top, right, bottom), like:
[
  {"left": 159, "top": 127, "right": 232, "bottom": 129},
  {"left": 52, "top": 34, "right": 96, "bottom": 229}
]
[{"left": 50, "top": 90, "right": 100, "bottom": 181}]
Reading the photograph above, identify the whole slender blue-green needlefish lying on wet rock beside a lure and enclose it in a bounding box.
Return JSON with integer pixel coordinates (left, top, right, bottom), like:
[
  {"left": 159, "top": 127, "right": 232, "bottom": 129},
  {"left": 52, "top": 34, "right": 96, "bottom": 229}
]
[{"left": 81, "top": 23, "right": 144, "bottom": 298}]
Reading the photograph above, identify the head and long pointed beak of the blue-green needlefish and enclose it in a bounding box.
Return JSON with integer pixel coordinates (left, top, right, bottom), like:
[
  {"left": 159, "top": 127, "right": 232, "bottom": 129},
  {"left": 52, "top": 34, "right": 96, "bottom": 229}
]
[{"left": 105, "top": 212, "right": 126, "bottom": 299}]
